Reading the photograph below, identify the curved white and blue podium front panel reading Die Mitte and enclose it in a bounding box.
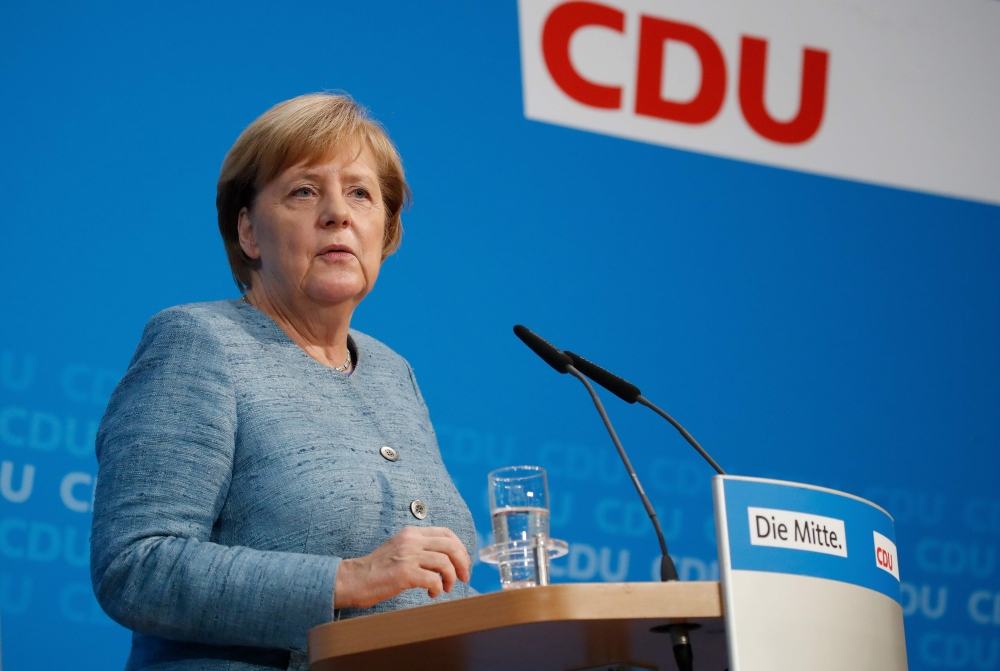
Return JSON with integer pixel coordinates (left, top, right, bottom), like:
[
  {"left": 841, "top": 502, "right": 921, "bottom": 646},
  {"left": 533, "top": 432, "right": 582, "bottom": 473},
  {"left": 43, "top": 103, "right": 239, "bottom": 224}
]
[{"left": 712, "top": 476, "right": 907, "bottom": 671}]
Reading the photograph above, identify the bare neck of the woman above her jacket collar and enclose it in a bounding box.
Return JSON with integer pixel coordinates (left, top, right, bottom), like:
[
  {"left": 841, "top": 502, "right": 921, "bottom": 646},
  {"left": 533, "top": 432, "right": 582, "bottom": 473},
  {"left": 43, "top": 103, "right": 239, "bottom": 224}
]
[{"left": 246, "top": 284, "right": 355, "bottom": 368}]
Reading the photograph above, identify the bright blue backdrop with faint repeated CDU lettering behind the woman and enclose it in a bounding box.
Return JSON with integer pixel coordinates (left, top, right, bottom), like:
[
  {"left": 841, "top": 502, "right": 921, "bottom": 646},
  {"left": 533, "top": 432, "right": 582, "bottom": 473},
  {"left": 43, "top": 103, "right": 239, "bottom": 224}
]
[{"left": 0, "top": 1, "right": 1000, "bottom": 671}]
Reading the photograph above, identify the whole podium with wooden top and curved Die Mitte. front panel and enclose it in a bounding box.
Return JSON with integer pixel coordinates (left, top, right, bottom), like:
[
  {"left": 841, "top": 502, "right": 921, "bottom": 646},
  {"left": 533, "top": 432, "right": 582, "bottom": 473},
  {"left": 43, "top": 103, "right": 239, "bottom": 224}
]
[{"left": 309, "top": 476, "right": 907, "bottom": 671}]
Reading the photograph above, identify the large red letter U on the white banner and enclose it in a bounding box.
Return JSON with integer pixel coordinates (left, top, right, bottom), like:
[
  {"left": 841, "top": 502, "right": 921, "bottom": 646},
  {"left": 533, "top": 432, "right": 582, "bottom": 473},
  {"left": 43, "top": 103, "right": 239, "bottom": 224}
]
[{"left": 740, "top": 35, "right": 829, "bottom": 144}]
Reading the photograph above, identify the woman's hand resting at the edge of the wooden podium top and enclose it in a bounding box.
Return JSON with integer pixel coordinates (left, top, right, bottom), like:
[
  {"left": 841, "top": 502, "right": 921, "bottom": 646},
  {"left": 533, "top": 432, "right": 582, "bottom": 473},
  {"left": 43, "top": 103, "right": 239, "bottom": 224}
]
[{"left": 333, "top": 527, "right": 472, "bottom": 608}]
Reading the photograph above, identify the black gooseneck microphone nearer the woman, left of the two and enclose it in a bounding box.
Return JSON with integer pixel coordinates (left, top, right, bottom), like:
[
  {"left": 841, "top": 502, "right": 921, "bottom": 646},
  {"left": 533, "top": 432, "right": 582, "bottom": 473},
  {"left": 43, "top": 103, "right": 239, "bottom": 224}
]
[{"left": 514, "top": 324, "right": 694, "bottom": 671}]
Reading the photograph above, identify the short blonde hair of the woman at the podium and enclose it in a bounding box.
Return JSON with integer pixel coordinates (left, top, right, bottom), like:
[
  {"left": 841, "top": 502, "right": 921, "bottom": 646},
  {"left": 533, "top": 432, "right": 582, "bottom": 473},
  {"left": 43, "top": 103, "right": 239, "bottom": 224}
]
[{"left": 215, "top": 93, "right": 412, "bottom": 292}]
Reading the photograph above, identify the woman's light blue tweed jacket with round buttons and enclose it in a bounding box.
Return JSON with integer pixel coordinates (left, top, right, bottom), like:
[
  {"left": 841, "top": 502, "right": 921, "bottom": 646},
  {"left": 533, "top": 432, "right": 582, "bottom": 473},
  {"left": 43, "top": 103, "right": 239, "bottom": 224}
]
[{"left": 91, "top": 301, "right": 475, "bottom": 671}]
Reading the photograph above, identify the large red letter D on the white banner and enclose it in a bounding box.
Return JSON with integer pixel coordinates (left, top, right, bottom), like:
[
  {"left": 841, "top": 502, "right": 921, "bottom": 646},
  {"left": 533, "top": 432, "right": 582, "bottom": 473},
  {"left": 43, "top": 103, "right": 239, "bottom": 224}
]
[{"left": 635, "top": 16, "right": 726, "bottom": 123}]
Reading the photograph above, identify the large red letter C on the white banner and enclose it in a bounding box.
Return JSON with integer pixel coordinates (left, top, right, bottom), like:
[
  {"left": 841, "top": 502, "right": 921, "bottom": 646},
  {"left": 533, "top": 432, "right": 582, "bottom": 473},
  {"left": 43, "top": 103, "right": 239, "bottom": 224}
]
[{"left": 542, "top": 2, "right": 625, "bottom": 109}]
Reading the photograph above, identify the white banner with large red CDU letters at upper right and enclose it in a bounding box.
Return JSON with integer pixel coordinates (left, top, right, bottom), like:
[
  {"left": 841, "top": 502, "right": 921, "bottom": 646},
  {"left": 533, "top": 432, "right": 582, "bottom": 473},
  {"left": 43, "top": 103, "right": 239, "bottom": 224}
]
[{"left": 519, "top": 0, "right": 1000, "bottom": 204}]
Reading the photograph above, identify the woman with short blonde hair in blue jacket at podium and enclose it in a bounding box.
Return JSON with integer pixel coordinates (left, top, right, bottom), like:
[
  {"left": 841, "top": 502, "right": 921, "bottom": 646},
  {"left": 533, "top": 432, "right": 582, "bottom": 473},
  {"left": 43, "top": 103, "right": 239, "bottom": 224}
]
[{"left": 91, "top": 94, "right": 475, "bottom": 670}]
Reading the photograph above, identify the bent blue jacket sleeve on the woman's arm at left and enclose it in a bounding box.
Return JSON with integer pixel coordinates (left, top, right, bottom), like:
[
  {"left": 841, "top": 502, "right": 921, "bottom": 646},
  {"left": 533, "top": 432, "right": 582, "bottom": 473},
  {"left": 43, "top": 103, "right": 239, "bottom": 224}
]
[{"left": 91, "top": 308, "right": 340, "bottom": 650}]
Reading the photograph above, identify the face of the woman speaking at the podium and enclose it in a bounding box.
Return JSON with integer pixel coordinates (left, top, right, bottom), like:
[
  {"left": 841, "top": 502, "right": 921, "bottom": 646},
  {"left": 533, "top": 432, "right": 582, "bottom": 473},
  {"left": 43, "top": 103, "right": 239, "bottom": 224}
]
[{"left": 239, "top": 147, "right": 386, "bottom": 305}]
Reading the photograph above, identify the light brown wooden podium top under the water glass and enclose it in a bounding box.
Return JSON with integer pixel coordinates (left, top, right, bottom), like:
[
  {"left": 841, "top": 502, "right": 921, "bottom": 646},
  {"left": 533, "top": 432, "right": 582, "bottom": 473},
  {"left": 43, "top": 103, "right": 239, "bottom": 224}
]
[{"left": 309, "top": 582, "right": 727, "bottom": 671}]
